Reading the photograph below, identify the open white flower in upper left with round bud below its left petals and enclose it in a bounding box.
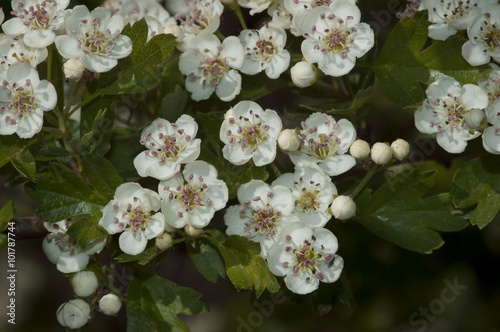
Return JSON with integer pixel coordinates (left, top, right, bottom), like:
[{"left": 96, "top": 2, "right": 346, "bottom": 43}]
[{"left": 55, "top": 5, "right": 132, "bottom": 73}]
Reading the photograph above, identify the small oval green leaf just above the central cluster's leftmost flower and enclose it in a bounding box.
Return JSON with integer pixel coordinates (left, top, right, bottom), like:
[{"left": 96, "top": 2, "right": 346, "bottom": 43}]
[{"left": 82, "top": 155, "right": 123, "bottom": 201}]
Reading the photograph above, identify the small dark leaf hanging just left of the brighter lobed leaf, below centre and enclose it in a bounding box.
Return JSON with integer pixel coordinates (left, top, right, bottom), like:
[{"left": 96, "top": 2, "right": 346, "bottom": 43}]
[{"left": 186, "top": 229, "right": 226, "bottom": 283}]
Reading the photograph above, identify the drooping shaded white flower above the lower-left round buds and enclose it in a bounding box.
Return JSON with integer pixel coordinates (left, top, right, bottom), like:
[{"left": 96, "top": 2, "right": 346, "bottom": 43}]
[{"left": 42, "top": 220, "right": 106, "bottom": 273}]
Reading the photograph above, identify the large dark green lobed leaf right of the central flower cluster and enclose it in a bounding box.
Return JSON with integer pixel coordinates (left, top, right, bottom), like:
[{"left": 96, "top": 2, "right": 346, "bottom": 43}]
[{"left": 354, "top": 169, "right": 467, "bottom": 253}]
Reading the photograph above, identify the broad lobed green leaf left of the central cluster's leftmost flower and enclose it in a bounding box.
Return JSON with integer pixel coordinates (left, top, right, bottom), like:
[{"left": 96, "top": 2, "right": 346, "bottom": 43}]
[{"left": 25, "top": 163, "right": 108, "bottom": 222}]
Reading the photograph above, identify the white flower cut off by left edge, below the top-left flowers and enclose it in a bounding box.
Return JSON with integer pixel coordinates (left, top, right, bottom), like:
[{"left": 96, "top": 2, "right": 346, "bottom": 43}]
[{"left": 0, "top": 62, "right": 57, "bottom": 138}]
